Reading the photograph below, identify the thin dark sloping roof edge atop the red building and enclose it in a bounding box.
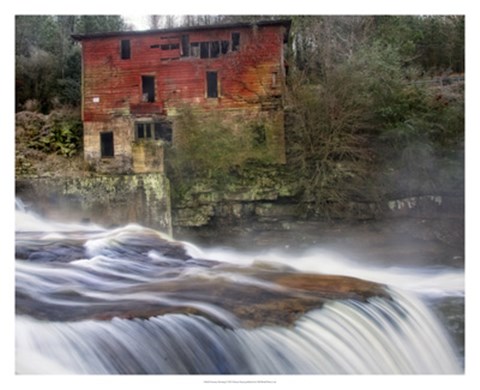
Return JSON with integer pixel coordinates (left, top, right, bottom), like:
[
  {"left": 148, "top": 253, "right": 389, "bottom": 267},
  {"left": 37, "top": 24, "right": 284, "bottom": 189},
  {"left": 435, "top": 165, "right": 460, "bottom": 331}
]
[{"left": 72, "top": 19, "right": 292, "bottom": 41}]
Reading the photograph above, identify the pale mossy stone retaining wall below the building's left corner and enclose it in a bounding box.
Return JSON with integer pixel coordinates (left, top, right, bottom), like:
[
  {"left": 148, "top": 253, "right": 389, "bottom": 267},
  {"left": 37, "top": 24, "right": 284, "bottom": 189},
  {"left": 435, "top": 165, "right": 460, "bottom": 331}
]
[{"left": 16, "top": 174, "right": 172, "bottom": 234}]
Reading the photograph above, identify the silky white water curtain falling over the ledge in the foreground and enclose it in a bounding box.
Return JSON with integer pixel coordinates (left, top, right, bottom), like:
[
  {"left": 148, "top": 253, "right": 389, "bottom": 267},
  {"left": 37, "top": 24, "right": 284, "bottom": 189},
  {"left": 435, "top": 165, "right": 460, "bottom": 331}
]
[{"left": 16, "top": 292, "right": 461, "bottom": 374}]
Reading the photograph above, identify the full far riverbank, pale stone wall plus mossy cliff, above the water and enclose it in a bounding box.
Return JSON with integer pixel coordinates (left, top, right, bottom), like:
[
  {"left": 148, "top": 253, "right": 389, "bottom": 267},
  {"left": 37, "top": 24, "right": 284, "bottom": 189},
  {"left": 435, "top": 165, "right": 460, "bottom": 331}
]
[{"left": 16, "top": 163, "right": 464, "bottom": 265}]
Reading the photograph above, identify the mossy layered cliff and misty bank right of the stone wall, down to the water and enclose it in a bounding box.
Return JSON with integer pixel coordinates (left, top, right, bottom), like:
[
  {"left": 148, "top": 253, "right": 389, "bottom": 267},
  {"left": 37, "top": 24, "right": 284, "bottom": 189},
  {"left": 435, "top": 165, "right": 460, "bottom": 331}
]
[{"left": 167, "top": 165, "right": 464, "bottom": 266}]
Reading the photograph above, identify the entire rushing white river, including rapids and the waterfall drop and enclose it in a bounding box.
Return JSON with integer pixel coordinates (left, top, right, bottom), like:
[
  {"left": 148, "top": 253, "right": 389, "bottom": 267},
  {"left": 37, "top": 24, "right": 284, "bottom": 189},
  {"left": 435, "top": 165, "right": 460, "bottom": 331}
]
[{"left": 16, "top": 203, "right": 463, "bottom": 374}]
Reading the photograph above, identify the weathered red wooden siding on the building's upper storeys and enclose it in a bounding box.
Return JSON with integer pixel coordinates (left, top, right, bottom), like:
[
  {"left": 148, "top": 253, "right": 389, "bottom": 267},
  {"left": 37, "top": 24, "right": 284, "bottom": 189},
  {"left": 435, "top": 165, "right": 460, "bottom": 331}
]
[{"left": 82, "top": 26, "right": 284, "bottom": 121}]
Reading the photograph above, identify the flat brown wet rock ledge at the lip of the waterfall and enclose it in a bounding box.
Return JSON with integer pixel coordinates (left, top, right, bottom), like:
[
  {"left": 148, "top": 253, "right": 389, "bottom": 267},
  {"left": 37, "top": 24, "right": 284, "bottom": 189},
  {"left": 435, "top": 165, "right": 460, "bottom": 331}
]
[{"left": 17, "top": 266, "right": 389, "bottom": 328}]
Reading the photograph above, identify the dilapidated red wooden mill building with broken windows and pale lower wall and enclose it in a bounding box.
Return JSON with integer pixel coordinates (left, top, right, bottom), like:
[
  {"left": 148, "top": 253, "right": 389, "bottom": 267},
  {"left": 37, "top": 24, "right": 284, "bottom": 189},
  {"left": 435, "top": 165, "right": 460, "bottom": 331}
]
[{"left": 74, "top": 20, "right": 290, "bottom": 172}]
